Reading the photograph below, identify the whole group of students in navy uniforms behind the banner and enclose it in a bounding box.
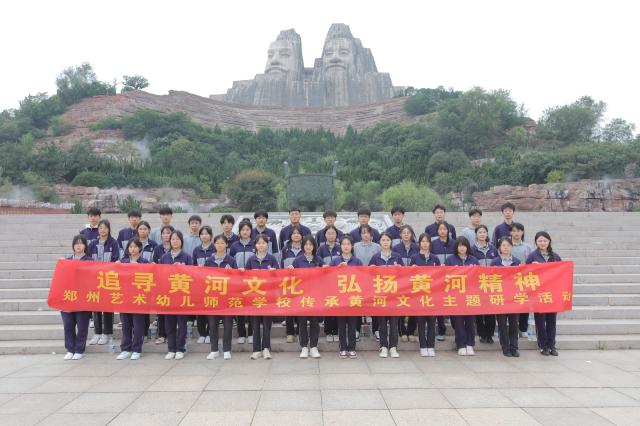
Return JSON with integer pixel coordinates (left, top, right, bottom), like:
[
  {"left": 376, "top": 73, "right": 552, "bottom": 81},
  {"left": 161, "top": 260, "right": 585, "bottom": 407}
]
[{"left": 61, "top": 203, "right": 561, "bottom": 360}]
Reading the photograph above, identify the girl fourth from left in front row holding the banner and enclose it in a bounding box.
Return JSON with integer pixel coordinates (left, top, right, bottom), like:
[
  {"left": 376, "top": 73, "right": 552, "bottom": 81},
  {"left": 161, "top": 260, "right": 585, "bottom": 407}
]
[{"left": 198, "top": 234, "right": 236, "bottom": 360}]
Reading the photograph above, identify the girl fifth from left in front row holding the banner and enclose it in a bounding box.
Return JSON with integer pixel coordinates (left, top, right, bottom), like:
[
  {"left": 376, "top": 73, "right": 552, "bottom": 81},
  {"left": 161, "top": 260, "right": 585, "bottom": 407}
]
[{"left": 245, "top": 234, "right": 280, "bottom": 359}]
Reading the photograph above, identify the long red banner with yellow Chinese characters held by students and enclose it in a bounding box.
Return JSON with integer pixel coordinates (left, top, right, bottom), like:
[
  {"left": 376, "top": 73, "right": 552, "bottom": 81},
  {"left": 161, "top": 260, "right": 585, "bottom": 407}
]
[{"left": 48, "top": 260, "right": 573, "bottom": 316}]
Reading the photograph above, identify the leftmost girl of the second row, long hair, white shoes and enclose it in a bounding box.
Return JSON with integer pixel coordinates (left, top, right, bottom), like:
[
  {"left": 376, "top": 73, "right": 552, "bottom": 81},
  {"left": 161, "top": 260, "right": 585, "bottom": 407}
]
[{"left": 89, "top": 219, "right": 120, "bottom": 345}]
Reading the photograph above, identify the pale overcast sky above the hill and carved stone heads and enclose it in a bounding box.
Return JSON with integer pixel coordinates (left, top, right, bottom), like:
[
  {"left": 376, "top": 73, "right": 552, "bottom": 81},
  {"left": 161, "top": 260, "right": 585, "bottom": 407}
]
[{"left": 0, "top": 0, "right": 640, "bottom": 126}]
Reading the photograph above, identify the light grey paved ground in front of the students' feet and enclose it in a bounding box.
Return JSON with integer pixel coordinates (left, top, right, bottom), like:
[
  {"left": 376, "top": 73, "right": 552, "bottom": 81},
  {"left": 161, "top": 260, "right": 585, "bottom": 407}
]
[{"left": 0, "top": 350, "right": 640, "bottom": 426}]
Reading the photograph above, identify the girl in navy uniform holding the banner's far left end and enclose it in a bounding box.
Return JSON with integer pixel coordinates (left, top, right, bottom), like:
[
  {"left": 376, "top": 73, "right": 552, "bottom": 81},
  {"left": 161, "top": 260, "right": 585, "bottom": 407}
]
[{"left": 60, "top": 234, "right": 93, "bottom": 361}]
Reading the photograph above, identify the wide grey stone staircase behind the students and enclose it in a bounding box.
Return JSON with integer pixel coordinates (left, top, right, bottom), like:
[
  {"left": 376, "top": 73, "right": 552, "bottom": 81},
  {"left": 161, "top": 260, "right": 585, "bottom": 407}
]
[{"left": 0, "top": 212, "right": 640, "bottom": 354}]
